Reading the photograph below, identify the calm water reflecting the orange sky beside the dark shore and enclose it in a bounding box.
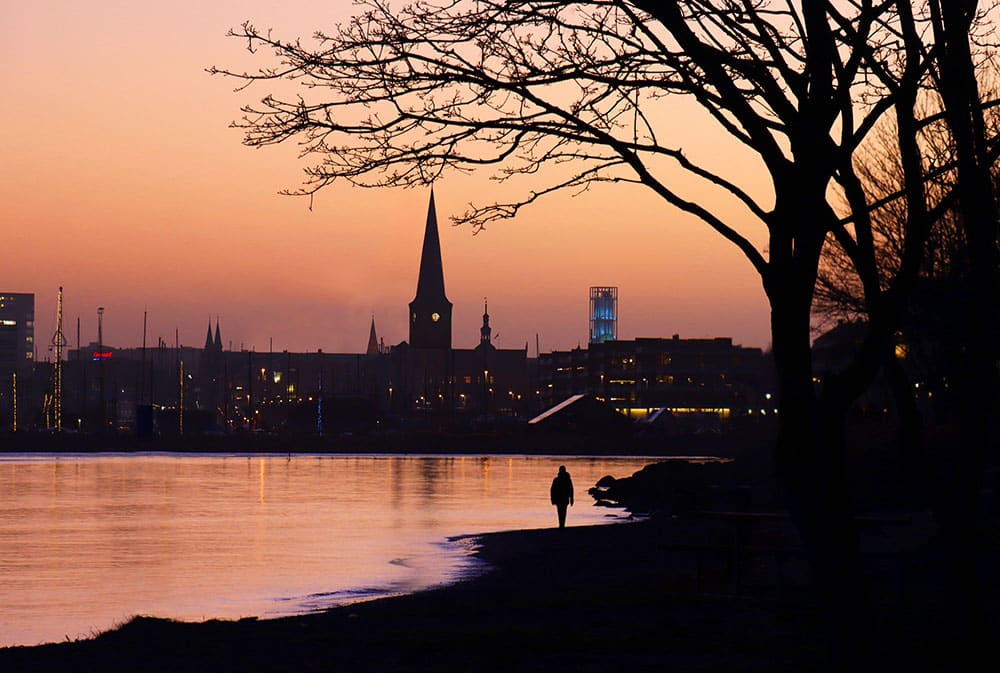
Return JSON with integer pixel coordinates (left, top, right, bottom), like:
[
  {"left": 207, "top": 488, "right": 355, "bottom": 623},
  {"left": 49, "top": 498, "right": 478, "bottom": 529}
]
[{"left": 0, "top": 454, "right": 652, "bottom": 646}]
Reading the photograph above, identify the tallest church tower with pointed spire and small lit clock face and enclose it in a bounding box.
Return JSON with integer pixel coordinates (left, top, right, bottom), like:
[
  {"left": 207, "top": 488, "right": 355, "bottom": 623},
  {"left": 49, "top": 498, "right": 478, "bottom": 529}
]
[{"left": 410, "top": 188, "right": 451, "bottom": 350}]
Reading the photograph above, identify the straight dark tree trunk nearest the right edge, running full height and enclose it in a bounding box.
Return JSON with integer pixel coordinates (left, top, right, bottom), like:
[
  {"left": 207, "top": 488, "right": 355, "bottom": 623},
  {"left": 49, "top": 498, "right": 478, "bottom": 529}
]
[{"left": 933, "top": 0, "right": 998, "bottom": 670}]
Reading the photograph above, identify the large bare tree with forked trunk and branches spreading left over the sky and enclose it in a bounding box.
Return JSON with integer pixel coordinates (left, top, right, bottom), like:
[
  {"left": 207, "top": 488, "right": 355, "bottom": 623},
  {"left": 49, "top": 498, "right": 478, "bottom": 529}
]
[{"left": 210, "top": 0, "right": 996, "bottom": 666}]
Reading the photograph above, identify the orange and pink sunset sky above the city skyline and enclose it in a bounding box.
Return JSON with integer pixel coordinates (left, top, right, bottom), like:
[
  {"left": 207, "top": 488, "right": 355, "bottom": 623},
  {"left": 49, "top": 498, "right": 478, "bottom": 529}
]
[{"left": 0, "top": 0, "right": 770, "bottom": 359}]
